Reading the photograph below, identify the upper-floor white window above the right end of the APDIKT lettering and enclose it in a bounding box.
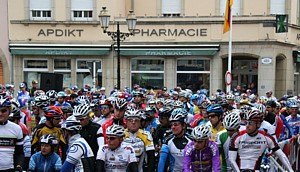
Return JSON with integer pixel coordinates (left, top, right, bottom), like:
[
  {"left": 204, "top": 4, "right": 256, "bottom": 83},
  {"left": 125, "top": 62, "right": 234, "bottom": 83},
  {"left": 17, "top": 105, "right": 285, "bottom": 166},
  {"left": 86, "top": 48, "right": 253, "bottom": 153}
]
[{"left": 71, "top": 0, "right": 93, "bottom": 21}]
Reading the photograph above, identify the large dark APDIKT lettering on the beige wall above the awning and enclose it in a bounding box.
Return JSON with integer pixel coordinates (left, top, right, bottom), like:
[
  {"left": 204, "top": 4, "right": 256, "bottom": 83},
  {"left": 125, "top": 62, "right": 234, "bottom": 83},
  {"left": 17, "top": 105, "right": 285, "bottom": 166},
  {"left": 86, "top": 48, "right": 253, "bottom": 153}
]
[{"left": 37, "top": 29, "right": 84, "bottom": 37}]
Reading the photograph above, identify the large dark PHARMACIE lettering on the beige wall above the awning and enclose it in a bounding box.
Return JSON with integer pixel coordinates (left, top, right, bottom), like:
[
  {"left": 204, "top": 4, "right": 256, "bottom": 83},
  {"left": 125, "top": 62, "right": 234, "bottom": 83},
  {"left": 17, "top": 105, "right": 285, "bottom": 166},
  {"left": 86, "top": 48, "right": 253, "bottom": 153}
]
[{"left": 134, "top": 28, "right": 207, "bottom": 37}]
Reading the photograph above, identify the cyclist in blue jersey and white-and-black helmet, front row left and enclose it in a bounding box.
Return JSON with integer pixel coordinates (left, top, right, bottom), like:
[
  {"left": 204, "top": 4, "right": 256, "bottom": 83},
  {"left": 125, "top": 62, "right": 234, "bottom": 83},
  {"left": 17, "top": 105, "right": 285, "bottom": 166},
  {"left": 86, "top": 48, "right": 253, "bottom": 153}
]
[{"left": 28, "top": 134, "right": 62, "bottom": 172}]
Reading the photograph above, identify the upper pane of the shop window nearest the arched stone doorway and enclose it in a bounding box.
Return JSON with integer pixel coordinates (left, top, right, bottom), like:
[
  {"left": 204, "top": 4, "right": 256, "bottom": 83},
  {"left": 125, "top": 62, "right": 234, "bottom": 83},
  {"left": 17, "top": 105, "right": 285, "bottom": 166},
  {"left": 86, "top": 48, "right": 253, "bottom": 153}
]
[{"left": 177, "top": 60, "right": 210, "bottom": 71}]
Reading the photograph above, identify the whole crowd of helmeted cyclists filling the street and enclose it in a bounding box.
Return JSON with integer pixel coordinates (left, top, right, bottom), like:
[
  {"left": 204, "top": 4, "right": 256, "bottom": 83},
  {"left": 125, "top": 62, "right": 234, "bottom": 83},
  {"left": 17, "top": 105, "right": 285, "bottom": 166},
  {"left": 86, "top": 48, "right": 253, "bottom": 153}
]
[{"left": 0, "top": 80, "right": 300, "bottom": 172}]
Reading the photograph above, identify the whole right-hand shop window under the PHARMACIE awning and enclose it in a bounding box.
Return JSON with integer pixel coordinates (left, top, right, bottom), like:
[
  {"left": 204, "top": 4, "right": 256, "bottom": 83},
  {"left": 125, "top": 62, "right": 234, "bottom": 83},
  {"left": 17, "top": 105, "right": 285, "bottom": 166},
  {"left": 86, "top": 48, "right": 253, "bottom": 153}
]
[{"left": 176, "top": 59, "right": 210, "bottom": 91}]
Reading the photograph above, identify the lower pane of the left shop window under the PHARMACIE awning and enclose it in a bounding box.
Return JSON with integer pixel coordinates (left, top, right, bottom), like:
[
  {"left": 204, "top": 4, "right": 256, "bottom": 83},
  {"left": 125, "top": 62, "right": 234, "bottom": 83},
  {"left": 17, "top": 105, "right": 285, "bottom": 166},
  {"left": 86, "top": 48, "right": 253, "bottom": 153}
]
[{"left": 131, "top": 73, "right": 164, "bottom": 89}]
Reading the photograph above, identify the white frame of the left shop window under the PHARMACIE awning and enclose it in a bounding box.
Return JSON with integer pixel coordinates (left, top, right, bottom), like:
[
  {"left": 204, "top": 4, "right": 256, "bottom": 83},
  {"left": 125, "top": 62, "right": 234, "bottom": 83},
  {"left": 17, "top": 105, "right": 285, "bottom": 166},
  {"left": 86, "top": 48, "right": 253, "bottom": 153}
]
[{"left": 130, "top": 57, "right": 166, "bottom": 88}]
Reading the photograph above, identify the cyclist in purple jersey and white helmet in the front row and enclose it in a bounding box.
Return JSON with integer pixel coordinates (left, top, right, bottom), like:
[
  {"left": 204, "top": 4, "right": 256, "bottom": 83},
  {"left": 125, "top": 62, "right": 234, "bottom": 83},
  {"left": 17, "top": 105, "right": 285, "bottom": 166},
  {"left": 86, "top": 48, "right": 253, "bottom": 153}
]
[{"left": 183, "top": 125, "right": 221, "bottom": 172}]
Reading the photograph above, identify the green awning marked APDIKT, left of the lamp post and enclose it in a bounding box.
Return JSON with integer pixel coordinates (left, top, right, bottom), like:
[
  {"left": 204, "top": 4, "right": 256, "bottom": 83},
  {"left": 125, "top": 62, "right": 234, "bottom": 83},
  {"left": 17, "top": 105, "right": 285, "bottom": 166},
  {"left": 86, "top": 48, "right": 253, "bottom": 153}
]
[{"left": 9, "top": 44, "right": 111, "bottom": 56}]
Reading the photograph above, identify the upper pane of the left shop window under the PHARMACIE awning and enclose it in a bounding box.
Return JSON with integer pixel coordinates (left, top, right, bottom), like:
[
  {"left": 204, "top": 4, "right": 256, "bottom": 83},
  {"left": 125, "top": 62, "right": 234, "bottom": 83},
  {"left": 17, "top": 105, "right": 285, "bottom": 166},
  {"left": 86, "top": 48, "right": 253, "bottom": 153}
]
[{"left": 131, "top": 59, "right": 164, "bottom": 71}]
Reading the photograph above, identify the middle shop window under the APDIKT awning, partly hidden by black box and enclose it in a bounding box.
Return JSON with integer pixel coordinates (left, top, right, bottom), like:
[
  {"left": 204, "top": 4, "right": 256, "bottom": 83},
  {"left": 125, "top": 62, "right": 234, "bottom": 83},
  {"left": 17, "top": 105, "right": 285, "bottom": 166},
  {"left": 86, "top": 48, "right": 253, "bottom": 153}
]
[{"left": 54, "top": 59, "right": 71, "bottom": 88}]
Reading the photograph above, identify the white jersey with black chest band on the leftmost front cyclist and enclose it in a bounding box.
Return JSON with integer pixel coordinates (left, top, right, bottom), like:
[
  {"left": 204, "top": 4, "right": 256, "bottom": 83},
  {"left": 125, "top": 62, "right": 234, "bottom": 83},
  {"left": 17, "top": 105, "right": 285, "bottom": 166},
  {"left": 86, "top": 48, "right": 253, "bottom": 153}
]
[{"left": 0, "top": 121, "right": 23, "bottom": 170}]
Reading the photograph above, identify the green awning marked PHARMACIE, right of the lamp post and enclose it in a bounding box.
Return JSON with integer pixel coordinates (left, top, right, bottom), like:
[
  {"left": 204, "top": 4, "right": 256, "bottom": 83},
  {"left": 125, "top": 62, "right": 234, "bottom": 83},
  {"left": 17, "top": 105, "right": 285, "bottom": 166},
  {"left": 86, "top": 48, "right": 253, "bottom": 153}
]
[{"left": 114, "top": 44, "right": 220, "bottom": 56}]
